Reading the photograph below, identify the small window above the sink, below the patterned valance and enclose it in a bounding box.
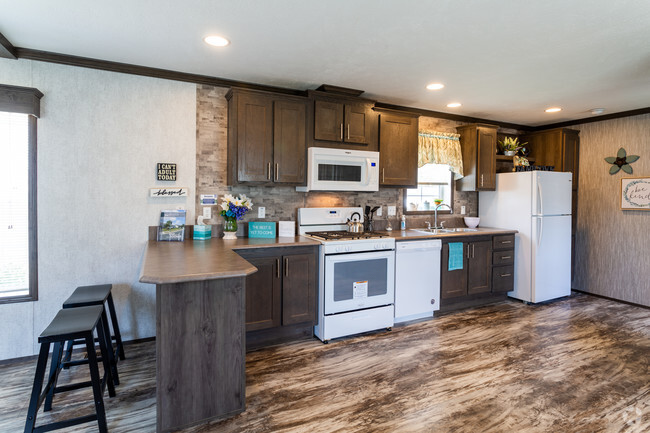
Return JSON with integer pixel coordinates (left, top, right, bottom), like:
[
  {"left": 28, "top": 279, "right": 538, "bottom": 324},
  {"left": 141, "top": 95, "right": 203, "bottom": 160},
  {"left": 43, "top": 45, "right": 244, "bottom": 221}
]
[{"left": 404, "top": 164, "right": 454, "bottom": 212}]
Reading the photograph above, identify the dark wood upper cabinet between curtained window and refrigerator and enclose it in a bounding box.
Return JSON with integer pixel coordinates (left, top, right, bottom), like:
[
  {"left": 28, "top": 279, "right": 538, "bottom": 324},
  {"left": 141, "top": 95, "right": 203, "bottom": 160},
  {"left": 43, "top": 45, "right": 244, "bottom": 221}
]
[{"left": 456, "top": 124, "right": 498, "bottom": 191}]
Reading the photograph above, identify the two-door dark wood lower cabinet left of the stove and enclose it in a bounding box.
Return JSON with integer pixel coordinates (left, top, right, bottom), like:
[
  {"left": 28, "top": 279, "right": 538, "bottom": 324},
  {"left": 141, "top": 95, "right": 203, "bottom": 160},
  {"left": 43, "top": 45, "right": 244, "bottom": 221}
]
[{"left": 237, "top": 247, "right": 318, "bottom": 349}]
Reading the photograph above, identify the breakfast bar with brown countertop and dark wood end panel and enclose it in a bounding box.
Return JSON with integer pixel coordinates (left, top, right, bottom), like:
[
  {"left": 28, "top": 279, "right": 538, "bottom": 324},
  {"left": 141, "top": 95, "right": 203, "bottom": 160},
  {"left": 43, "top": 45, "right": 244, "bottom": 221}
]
[{"left": 140, "top": 236, "right": 318, "bottom": 432}]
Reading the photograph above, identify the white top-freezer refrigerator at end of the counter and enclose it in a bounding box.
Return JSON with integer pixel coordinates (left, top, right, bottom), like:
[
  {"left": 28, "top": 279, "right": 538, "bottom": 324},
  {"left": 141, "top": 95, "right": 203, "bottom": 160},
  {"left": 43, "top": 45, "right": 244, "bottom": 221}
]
[{"left": 479, "top": 171, "right": 572, "bottom": 303}]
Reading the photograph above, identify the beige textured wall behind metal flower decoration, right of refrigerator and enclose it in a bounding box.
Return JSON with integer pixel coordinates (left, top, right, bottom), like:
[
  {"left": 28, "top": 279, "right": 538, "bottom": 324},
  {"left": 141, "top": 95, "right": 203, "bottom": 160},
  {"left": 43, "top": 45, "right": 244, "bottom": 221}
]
[{"left": 572, "top": 114, "right": 650, "bottom": 306}]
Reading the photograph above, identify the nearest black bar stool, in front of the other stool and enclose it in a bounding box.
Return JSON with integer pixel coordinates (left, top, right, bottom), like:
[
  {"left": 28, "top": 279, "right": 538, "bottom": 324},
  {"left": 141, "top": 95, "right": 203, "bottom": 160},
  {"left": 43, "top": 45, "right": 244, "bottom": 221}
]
[{"left": 25, "top": 305, "right": 115, "bottom": 433}]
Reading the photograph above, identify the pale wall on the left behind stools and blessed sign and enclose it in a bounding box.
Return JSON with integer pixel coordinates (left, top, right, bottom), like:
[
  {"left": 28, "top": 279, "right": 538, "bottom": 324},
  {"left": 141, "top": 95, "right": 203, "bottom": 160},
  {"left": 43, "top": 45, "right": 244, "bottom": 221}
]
[{"left": 0, "top": 59, "right": 196, "bottom": 359}]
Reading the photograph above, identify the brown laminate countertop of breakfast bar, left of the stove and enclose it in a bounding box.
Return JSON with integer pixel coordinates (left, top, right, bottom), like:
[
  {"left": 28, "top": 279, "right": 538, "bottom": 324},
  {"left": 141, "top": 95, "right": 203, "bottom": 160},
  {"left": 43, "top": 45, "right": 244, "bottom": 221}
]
[{"left": 140, "top": 236, "right": 320, "bottom": 284}]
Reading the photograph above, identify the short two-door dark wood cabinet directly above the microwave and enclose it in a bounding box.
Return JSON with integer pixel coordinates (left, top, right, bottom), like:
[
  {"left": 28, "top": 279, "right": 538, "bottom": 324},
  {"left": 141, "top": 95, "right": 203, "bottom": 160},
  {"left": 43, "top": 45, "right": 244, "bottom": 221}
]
[{"left": 307, "top": 90, "right": 378, "bottom": 151}]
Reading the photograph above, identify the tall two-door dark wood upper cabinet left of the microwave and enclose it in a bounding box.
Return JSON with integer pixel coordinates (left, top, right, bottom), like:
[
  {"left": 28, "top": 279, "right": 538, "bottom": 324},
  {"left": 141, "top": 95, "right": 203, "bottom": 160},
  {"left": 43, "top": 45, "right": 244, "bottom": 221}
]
[{"left": 226, "top": 89, "right": 307, "bottom": 185}]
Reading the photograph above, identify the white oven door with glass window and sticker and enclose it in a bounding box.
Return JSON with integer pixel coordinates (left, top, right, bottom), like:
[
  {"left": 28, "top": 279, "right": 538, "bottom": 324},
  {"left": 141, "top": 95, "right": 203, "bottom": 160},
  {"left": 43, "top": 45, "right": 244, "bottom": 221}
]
[{"left": 324, "top": 250, "right": 395, "bottom": 314}]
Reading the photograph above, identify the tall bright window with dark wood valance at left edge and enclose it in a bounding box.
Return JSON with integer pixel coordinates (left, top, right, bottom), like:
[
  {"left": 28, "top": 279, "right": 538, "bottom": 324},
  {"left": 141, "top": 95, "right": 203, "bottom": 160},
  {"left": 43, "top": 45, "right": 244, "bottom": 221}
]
[{"left": 0, "top": 85, "right": 43, "bottom": 303}]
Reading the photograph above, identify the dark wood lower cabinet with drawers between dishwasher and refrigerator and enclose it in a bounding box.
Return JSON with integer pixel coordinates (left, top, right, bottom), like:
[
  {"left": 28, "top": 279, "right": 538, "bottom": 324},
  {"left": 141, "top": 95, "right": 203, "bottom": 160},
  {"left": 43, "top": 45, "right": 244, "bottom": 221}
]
[{"left": 440, "top": 235, "right": 514, "bottom": 311}]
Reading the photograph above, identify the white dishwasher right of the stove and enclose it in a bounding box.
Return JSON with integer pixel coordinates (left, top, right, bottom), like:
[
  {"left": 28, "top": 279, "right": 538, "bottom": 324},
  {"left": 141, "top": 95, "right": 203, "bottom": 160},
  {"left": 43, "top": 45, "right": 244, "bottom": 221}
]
[{"left": 395, "top": 239, "right": 442, "bottom": 323}]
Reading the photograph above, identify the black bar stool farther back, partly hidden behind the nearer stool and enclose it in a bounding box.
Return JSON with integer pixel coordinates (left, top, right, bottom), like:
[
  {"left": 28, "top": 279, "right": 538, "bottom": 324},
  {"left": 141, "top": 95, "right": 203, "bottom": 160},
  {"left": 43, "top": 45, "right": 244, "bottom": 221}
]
[{"left": 63, "top": 284, "right": 125, "bottom": 385}]
